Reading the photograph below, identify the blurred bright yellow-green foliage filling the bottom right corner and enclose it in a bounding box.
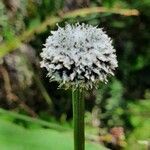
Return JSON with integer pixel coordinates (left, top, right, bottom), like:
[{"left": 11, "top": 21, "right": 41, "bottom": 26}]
[{"left": 127, "top": 99, "right": 150, "bottom": 150}]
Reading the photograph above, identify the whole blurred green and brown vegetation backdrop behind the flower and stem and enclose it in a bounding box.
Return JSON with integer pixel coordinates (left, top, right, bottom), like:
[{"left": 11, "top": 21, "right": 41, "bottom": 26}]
[{"left": 0, "top": 0, "right": 150, "bottom": 150}]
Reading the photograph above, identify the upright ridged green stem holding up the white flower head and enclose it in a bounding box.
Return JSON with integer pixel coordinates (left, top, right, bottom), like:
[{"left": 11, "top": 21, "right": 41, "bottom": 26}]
[{"left": 72, "top": 87, "right": 85, "bottom": 150}]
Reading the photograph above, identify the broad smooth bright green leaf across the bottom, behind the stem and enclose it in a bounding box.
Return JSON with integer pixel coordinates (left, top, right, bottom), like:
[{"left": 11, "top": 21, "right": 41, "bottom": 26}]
[{"left": 0, "top": 120, "right": 105, "bottom": 150}]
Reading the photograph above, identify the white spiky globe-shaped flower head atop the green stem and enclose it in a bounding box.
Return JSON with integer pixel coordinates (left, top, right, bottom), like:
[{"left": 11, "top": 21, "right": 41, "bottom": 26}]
[{"left": 41, "top": 23, "right": 118, "bottom": 89}]
